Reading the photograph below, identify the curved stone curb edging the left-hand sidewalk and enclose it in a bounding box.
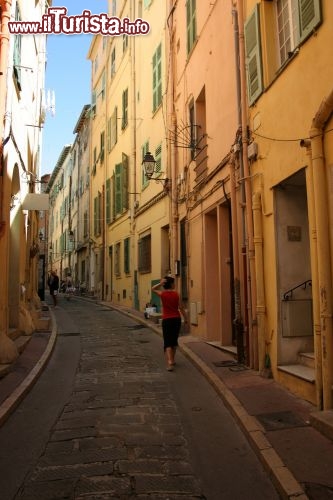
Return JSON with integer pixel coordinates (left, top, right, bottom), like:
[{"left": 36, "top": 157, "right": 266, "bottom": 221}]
[{"left": 0, "top": 309, "right": 57, "bottom": 426}]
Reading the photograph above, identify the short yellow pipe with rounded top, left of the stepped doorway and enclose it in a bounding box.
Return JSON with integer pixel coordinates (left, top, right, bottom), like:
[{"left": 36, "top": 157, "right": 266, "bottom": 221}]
[{"left": 252, "top": 192, "right": 268, "bottom": 374}]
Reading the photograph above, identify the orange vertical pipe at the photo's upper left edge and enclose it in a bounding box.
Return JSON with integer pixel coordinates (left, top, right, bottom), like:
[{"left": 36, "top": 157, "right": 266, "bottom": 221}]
[{"left": 0, "top": 0, "right": 12, "bottom": 238}]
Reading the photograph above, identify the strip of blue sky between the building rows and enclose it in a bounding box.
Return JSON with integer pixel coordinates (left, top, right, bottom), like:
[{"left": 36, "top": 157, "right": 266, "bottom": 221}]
[{"left": 41, "top": 0, "right": 108, "bottom": 175}]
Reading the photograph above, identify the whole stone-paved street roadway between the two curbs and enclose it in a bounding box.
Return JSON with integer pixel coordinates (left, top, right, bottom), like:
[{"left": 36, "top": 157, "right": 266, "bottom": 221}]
[{"left": 0, "top": 299, "right": 278, "bottom": 500}]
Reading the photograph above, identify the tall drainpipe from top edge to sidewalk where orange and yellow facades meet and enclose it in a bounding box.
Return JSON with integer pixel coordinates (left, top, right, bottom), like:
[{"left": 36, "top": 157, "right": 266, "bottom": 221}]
[{"left": 233, "top": 0, "right": 256, "bottom": 371}]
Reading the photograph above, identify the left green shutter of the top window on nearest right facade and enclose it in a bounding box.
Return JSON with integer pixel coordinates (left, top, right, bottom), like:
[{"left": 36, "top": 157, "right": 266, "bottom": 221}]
[{"left": 245, "top": 4, "right": 263, "bottom": 104}]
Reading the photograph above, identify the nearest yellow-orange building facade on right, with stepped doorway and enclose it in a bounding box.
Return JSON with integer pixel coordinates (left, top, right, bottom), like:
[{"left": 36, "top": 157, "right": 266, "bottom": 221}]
[{"left": 244, "top": 0, "right": 333, "bottom": 409}]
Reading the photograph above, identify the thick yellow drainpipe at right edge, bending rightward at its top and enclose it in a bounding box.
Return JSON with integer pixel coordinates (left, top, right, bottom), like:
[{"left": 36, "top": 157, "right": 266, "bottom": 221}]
[{"left": 310, "top": 91, "right": 333, "bottom": 410}]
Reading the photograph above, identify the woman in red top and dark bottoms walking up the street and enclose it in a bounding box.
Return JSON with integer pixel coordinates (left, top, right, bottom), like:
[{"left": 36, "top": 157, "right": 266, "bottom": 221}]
[{"left": 152, "top": 276, "right": 187, "bottom": 371}]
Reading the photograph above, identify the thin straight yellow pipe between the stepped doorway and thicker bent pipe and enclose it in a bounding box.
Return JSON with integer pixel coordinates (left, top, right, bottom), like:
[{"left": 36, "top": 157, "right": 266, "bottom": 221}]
[{"left": 301, "top": 141, "right": 323, "bottom": 410}]
